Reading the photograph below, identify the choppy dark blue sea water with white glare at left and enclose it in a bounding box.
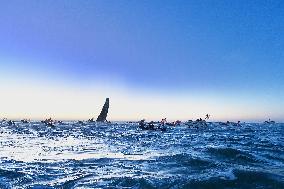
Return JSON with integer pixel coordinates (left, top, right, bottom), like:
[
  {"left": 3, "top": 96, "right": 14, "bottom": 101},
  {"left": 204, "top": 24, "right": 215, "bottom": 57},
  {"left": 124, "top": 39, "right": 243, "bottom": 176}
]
[{"left": 0, "top": 122, "right": 284, "bottom": 189}]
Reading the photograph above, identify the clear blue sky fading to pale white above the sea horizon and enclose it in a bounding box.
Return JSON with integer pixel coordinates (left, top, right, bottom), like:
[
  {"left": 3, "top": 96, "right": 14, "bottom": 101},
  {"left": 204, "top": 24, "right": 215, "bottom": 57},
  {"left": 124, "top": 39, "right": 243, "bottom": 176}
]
[{"left": 0, "top": 0, "right": 284, "bottom": 121}]
